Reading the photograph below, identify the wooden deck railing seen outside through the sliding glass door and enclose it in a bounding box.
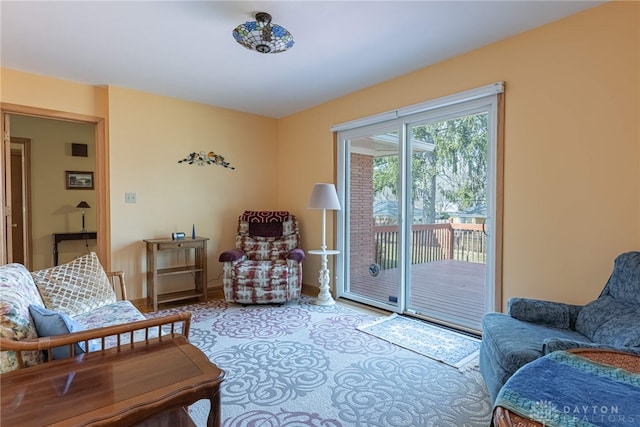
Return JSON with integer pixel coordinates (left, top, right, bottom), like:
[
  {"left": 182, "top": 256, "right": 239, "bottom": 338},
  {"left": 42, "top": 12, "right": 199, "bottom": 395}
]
[{"left": 374, "top": 223, "right": 486, "bottom": 270}]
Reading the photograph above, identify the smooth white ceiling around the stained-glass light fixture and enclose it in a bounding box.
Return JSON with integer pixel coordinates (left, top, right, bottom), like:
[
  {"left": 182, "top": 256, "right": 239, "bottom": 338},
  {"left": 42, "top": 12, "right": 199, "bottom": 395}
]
[{"left": 0, "top": 0, "right": 603, "bottom": 118}]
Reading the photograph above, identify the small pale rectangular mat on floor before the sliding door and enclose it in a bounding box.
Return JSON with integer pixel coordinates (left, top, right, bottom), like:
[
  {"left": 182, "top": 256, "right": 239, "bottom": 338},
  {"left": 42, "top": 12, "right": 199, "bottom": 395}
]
[{"left": 356, "top": 313, "right": 480, "bottom": 369}]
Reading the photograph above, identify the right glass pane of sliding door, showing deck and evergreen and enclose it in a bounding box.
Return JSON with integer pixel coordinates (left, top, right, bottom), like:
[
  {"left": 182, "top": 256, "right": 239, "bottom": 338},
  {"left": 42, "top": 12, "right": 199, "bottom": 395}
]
[{"left": 406, "top": 112, "right": 488, "bottom": 330}]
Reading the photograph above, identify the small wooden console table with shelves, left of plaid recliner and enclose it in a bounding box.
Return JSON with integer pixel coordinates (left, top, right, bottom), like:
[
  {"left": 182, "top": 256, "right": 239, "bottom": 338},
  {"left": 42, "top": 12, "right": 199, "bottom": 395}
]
[{"left": 145, "top": 237, "right": 209, "bottom": 311}]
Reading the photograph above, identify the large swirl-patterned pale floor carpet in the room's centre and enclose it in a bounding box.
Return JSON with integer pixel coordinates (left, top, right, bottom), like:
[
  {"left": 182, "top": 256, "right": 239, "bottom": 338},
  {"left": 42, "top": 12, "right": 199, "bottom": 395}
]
[{"left": 149, "top": 298, "right": 491, "bottom": 427}]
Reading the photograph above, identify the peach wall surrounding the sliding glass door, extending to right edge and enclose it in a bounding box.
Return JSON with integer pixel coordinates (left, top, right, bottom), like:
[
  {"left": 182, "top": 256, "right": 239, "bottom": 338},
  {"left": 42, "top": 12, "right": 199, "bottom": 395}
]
[{"left": 278, "top": 2, "right": 640, "bottom": 303}]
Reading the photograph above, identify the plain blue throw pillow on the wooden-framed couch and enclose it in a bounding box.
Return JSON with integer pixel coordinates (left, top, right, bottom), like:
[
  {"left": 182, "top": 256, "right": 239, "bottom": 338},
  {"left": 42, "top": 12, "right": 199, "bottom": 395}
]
[{"left": 29, "top": 305, "right": 93, "bottom": 360}]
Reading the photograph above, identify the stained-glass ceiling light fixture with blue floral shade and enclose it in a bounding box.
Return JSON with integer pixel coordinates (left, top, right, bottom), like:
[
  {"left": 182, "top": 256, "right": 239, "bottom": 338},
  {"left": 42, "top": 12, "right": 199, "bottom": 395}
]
[{"left": 233, "top": 12, "right": 294, "bottom": 53}]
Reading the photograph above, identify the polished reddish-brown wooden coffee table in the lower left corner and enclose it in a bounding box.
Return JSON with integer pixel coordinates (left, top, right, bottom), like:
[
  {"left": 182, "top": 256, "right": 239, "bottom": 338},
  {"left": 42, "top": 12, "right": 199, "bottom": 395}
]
[{"left": 0, "top": 336, "right": 224, "bottom": 426}]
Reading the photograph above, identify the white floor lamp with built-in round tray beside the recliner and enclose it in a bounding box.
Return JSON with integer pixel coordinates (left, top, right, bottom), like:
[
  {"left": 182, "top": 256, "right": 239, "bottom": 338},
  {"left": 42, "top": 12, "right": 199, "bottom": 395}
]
[{"left": 307, "top": 183, "right": 340, "bottom": 305}]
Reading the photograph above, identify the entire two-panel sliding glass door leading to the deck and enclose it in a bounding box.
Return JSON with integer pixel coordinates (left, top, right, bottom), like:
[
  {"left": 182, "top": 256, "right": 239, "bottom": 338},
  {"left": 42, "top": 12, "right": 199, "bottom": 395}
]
[{"left": 337, "top": 84, "right": 497, "bottom": 331}]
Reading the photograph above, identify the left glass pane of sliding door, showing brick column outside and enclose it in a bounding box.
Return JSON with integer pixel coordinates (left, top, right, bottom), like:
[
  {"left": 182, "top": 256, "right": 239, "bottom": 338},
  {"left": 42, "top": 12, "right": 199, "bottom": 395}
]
[{"left": 344, "top": 130, "right": 402, "bottom": 310}]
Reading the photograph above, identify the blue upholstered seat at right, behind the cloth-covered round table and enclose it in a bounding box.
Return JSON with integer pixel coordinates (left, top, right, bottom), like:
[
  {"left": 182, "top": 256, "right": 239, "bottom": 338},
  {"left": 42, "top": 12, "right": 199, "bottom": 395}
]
[{"left": 480, "top": 252, "right": 640, "bottom": 402}]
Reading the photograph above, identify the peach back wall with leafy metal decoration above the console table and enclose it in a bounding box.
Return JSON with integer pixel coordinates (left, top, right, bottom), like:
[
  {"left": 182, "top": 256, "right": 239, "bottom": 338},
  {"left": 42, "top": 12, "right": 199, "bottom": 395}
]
[{"left": 109, "top": 87, "right": 278, "bottom": 298}]
